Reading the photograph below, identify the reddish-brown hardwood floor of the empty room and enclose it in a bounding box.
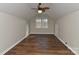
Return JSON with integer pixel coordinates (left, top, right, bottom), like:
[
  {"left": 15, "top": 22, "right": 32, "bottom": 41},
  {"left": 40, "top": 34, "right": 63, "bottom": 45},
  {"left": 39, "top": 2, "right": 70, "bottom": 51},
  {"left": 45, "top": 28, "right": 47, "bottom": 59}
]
[{"left": 5, "top": 34, "right": 74, "bottom": 55}]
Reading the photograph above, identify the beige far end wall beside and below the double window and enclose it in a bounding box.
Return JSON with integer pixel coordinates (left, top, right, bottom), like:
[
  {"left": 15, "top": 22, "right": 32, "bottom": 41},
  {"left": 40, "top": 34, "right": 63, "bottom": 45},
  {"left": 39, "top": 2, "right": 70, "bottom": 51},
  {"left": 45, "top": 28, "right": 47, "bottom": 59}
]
[{"left": 29, "top": 15, "right": 54, "bottom": 34}]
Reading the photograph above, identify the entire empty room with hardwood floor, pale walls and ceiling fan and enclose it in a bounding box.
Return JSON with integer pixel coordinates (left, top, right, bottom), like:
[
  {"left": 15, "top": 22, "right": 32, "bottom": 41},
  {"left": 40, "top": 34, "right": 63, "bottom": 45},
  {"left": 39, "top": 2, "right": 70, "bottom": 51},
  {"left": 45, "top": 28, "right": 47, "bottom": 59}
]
[{"left": 0, "top": 3, "right": 79, "bottom": 55}]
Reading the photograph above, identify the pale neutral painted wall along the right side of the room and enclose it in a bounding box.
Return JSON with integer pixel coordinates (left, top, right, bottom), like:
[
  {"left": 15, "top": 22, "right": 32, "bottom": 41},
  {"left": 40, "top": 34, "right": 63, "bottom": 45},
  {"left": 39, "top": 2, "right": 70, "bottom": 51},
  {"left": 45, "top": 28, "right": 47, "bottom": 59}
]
[{"left": 55, "top": 11, "right": 79, "bottom": 54}]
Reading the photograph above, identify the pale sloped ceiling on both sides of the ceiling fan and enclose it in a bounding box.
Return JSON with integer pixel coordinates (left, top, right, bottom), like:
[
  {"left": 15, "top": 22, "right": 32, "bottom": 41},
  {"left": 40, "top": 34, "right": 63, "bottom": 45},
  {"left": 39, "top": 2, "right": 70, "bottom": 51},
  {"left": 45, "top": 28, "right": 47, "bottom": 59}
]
[{"left": 0, "top": 3, "right": 79, "bottom": 19}]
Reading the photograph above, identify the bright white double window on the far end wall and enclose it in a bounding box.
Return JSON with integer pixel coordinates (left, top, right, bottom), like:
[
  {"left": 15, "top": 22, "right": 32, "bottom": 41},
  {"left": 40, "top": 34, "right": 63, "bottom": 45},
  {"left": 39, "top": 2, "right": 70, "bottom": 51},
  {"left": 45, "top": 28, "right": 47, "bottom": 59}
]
[{"left": 36, "top": 19, "right": 48, "bottom": 28}]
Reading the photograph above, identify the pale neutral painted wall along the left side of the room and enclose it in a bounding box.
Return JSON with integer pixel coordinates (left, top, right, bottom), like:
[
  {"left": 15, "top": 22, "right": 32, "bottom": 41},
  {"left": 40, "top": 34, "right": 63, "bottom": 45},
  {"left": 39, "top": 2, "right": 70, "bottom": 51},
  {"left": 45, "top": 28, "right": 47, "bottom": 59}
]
[{"left": 0, "top": 12, "right": 28, "bottom": 53}]
